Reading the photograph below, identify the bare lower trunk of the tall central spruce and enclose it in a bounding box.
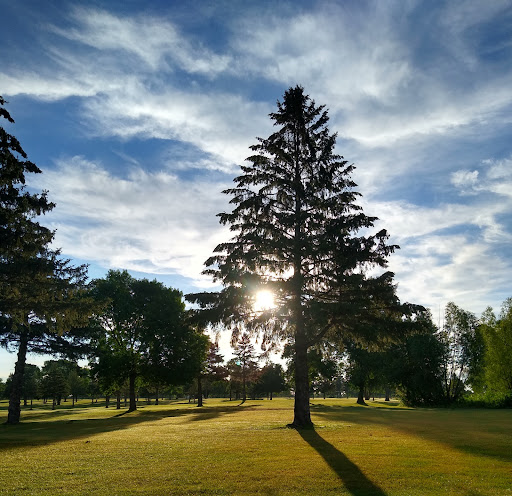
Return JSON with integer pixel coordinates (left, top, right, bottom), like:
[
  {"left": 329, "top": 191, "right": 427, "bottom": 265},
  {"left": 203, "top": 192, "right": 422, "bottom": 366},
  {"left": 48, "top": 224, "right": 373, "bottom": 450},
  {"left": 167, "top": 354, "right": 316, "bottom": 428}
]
[{"left": 290, "top": 336, "right": 313, "bottom": 429}]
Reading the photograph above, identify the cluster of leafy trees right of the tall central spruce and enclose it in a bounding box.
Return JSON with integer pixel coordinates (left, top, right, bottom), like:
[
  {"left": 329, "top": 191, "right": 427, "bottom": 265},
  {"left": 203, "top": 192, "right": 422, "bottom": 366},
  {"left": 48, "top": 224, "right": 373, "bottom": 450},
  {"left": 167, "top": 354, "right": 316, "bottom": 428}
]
[{"left": 340, "top": 298, "right": 512, "bottom": 406}]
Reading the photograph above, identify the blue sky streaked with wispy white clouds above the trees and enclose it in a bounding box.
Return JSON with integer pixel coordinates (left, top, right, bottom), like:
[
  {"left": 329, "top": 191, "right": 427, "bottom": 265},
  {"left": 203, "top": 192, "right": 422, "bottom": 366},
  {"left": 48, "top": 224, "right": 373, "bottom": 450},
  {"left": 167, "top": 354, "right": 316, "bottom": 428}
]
[{"left": 0, "top": 0, "right": 512, "bottom": 378}]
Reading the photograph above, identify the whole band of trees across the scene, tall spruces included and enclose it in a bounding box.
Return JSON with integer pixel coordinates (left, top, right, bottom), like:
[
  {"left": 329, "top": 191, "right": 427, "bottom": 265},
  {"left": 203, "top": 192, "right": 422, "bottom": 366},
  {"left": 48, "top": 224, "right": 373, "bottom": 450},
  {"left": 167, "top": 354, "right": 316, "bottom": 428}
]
[{"left": 0, "top": 90, "right": 511, "bottom": 428}]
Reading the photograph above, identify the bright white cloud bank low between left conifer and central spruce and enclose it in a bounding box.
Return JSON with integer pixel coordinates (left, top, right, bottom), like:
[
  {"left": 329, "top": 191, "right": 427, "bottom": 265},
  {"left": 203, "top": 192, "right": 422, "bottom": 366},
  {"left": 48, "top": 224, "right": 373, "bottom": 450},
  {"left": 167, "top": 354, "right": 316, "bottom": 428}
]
[{"left": 33, "top": 157, "right": 229, "bottom": 286}]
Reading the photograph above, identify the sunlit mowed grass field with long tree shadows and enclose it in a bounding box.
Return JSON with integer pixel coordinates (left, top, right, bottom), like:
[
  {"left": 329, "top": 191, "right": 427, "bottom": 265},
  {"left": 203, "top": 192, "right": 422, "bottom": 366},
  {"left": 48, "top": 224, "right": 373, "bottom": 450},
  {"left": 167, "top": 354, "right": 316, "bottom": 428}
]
[{"left": 0, "top": 398, "right": 512, "bottom": 496}]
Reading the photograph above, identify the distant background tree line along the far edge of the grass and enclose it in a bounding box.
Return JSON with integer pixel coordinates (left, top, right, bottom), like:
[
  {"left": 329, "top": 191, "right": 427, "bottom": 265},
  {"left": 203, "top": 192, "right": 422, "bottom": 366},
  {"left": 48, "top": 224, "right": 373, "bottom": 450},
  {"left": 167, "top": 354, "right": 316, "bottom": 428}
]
[{"left": 0, "top": 298, "right": 512, "bottom": 408}]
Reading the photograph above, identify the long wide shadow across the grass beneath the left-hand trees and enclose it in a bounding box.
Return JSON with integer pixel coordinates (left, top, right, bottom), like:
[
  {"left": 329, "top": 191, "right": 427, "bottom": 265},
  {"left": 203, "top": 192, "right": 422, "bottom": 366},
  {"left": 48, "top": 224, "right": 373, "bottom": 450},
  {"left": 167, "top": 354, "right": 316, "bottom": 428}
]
[{"left": 0, "top": 405, "right": 257, "bottom": 452}]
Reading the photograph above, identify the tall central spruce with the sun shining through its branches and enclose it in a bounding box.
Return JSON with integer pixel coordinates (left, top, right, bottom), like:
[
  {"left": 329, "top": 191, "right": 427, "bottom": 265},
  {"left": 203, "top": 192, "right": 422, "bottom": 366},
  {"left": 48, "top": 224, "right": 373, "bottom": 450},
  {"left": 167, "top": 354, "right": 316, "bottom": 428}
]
[{"left": 188, "top": 86, "right": 420, "bottom": 427}]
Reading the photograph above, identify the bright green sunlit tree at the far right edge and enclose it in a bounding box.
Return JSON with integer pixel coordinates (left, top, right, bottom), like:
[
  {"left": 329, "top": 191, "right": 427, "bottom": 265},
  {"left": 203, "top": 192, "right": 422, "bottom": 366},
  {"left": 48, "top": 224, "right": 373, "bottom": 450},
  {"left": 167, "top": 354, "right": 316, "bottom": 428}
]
[{"left": 482, "top": 298, "right": 512, "bottom": 395}]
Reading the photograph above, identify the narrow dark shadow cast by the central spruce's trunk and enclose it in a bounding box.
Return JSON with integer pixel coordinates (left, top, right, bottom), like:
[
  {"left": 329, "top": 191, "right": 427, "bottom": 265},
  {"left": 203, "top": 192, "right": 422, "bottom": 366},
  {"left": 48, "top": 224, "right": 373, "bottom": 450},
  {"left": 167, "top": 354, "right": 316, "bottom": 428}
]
[{"left": 297, "top": 429, "right": 386, "bottom": 496}]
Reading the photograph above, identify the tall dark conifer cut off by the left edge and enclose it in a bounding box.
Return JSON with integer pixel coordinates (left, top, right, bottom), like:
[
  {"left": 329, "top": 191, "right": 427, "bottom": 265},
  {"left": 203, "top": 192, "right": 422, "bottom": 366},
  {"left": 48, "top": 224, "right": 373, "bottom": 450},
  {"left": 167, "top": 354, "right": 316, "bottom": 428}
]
[{"left": 0, "top": 97, "right": 91, "bottom": 424}]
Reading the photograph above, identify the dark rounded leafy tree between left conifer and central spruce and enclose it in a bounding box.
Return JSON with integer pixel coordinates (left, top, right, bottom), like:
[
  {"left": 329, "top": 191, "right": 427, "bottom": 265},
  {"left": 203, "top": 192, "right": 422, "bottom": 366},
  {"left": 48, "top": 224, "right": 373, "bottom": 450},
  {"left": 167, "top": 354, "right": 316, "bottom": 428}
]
[{"left": 89, "top": 270, "right": 206, "bottom": 411}]
